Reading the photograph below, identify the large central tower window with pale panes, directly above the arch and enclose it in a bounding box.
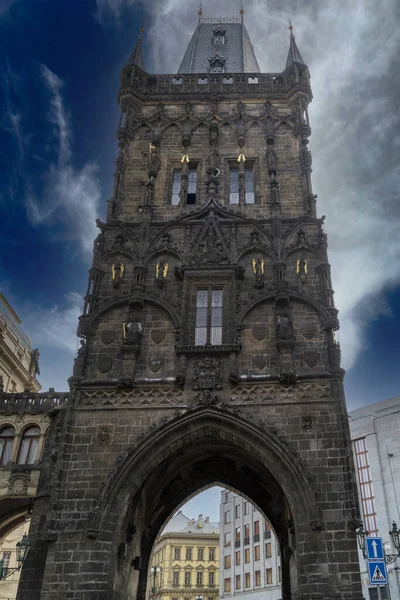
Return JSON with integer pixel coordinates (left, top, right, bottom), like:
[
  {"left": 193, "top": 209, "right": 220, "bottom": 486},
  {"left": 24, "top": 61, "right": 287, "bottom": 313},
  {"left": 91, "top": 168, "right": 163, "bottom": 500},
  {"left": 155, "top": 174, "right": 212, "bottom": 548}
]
[{"left": 195, "top": 288, "right": 223, "bottom": 344}]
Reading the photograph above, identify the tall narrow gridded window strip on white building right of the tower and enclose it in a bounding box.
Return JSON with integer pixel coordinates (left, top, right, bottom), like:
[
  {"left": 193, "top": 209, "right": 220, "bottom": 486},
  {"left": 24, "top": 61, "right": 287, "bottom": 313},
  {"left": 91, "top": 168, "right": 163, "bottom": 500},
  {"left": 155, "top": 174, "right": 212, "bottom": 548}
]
[{"left": 354, "top": 438, "right": 379, "bottom": 536}]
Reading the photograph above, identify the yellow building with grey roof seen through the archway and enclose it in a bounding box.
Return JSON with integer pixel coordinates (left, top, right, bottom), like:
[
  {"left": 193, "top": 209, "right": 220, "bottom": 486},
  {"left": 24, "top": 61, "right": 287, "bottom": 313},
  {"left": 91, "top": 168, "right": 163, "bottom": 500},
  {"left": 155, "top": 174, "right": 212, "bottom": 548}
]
[{"left": 148, "top": 512, "right": 219, "bottom": 600}]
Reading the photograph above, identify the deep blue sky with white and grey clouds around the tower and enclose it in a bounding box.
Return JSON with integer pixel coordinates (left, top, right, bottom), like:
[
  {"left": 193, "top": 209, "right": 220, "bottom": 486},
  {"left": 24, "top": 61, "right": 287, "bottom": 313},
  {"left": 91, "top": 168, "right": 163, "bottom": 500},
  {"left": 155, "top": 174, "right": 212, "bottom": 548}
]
[{"left": 0, "top": 0, "right": 400, "bottom": 408}]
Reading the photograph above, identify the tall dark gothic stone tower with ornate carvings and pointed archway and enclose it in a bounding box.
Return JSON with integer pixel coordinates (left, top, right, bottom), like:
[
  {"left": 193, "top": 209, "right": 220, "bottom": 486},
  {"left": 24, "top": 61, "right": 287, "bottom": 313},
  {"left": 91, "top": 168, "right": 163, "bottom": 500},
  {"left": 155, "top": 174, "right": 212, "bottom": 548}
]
[{"left": 18, "top": 14, "right": 361, "bottom": 600}]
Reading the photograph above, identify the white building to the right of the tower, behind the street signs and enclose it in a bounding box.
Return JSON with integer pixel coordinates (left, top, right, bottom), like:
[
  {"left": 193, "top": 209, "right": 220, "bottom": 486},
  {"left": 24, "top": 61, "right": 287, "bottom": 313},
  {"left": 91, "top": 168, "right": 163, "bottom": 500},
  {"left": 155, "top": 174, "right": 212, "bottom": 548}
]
[{"left": 349, "top": 396, "right": 400, "bottom": 600}]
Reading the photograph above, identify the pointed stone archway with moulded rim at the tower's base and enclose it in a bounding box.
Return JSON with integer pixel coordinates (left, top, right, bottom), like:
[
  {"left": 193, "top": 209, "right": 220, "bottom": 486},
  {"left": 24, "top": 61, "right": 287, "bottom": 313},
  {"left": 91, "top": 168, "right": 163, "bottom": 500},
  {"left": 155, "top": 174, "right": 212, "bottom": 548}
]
[{"left": 98, "top": 407, "right": 318, "bottom": 600}]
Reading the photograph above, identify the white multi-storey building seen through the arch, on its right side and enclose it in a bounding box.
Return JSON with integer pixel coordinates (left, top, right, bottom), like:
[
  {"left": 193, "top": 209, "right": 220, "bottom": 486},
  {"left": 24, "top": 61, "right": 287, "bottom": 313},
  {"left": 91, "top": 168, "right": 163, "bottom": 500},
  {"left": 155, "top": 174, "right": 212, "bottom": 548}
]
[{"left": 219, "top": 490, "right": 282, "bottom": 600}]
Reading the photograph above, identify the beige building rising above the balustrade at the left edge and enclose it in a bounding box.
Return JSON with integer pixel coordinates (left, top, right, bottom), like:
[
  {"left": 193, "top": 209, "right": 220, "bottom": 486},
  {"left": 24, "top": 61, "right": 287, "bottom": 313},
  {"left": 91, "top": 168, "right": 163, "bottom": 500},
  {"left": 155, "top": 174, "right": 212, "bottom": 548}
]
[{"left": 0, "top": 294, "right": 42, "bottom": 392}]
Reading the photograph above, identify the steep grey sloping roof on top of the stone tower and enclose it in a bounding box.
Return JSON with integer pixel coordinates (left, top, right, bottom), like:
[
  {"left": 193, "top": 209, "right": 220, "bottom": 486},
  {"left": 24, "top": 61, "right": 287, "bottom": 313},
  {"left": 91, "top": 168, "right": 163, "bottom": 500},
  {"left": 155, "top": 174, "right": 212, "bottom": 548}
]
[{"left": 178, "top": 20, "right": 260, "bottom": 73}]
